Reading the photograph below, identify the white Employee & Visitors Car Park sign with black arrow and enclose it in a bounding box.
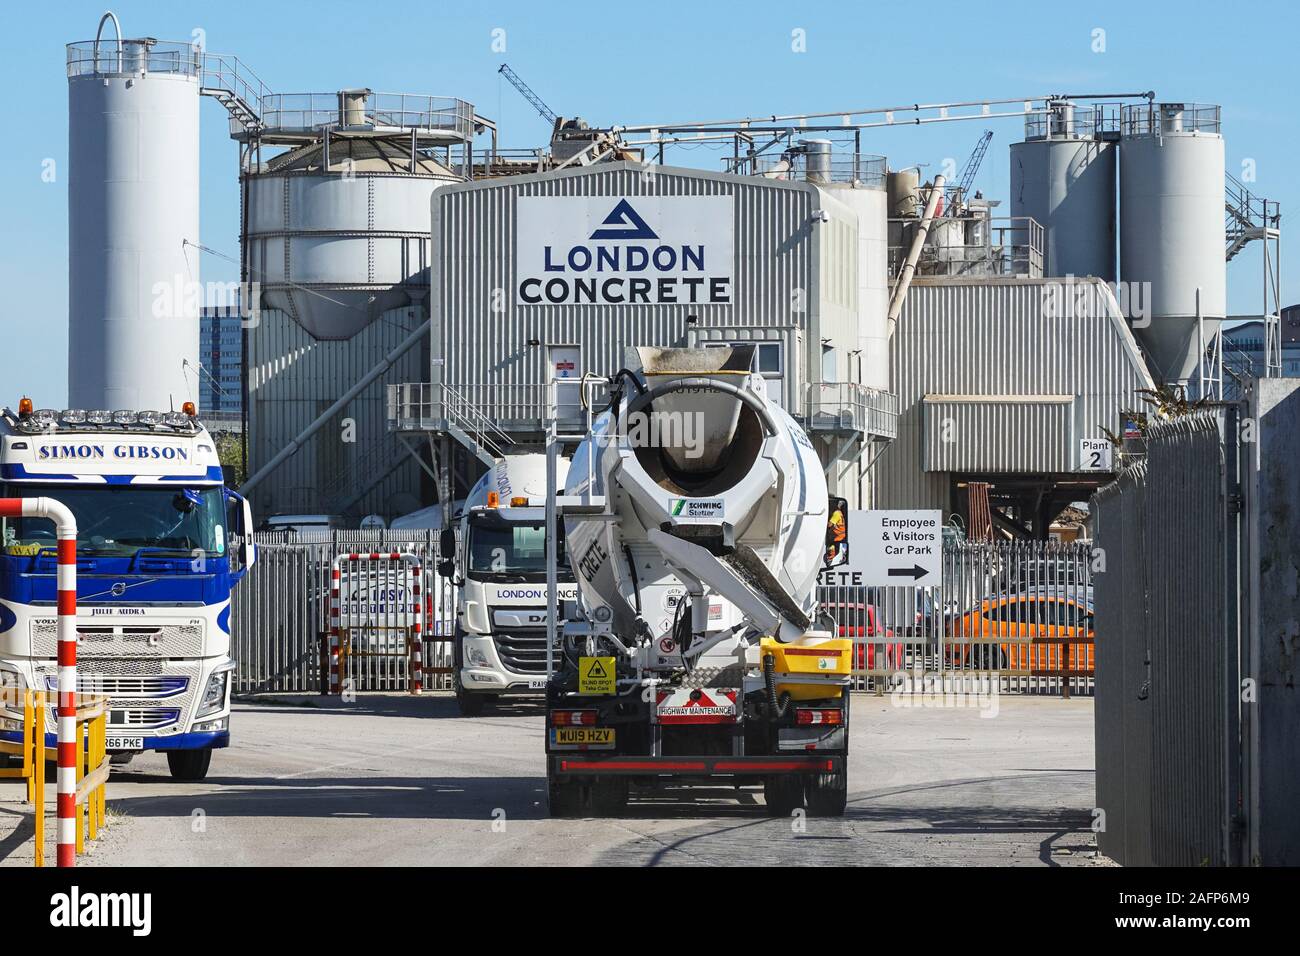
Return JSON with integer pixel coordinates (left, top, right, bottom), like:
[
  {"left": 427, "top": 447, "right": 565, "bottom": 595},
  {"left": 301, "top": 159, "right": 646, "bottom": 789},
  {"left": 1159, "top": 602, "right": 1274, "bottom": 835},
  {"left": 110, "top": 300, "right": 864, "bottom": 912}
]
[{"left": 822, "top": 510, "right": 944, "bottom": 588}]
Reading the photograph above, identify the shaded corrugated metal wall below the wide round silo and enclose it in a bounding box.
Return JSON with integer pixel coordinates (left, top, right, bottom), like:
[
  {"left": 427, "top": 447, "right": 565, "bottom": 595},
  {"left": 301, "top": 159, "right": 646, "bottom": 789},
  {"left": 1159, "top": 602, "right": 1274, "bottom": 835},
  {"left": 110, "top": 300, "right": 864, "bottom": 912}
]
[{"left": 247, "top": 307, "right": 428, "bottom": 519}]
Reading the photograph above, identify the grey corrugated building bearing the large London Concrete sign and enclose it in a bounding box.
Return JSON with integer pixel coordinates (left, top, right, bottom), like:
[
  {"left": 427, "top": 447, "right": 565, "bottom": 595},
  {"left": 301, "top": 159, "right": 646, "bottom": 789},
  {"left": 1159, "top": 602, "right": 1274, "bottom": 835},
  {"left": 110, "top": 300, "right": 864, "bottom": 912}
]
[{"left": 393, "top": 161, "right": 893, "bottom": 501}]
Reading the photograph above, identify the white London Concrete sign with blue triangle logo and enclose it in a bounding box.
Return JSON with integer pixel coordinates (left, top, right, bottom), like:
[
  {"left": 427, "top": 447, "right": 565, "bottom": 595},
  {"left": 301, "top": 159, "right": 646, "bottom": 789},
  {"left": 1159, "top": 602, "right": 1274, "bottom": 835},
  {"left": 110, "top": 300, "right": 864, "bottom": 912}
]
[{"left": 515, "top": 196, "right": 735, "bottom": 306}]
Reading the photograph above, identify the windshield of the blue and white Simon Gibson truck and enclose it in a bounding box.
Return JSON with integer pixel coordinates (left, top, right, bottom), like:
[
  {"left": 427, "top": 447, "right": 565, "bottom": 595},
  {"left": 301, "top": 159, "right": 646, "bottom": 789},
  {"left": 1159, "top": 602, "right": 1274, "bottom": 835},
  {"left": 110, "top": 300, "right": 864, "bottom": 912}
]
[{"left": 0, "top": 485, "right": 226, "bottom": 557}]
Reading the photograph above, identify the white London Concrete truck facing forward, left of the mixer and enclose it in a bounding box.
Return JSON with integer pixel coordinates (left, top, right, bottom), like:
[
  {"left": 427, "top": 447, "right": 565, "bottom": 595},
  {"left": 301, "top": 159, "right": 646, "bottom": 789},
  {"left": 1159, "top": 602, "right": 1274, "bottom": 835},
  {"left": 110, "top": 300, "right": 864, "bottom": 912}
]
[{"left": 438, "top": 454, "right": 577, "bottom": 717}]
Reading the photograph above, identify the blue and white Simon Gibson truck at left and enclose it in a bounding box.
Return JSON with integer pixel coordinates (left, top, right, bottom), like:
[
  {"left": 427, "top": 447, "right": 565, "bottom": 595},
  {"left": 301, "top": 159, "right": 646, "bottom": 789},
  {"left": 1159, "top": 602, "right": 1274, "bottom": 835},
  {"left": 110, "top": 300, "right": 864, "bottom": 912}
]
[{"left": 0, "top": 398, "right": 255, "bottom": 780}]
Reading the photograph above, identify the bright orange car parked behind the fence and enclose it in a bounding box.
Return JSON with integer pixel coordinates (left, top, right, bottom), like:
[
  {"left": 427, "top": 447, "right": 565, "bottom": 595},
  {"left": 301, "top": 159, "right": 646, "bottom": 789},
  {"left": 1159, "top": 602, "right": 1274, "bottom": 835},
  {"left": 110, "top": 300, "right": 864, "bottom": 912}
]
[{"left": 949, "top": 588, "right": 1093, "bottom": 676}]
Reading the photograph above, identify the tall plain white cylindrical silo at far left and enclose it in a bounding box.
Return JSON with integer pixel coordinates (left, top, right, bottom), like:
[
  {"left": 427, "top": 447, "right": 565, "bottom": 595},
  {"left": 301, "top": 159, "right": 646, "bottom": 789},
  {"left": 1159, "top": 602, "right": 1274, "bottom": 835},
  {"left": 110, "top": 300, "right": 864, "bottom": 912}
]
[{"left": 68, "top": 24, "right": 203, "bottom": 410}]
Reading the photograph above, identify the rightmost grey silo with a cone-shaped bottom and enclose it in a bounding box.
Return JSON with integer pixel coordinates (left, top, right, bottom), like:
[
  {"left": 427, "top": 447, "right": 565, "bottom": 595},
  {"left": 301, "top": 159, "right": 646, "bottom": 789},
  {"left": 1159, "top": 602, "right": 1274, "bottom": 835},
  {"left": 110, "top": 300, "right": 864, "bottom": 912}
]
[{"left": 1119, "top": 103, "right": 1227, "bottom": 382}]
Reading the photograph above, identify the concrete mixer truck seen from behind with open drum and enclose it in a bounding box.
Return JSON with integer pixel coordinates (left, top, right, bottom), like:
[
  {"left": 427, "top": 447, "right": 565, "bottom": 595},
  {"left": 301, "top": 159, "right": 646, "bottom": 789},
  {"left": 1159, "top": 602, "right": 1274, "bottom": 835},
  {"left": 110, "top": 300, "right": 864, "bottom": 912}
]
[{"left": 546, "top": 346, "right": 853, "bottom": 816}]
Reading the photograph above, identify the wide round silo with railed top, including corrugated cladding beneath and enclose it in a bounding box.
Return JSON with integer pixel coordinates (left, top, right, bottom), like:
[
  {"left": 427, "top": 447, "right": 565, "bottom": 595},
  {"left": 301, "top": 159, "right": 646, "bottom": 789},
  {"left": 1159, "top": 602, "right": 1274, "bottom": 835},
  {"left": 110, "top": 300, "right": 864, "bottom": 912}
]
[{"left": 237, "top": 90, "right": 473, "bottom": 518}]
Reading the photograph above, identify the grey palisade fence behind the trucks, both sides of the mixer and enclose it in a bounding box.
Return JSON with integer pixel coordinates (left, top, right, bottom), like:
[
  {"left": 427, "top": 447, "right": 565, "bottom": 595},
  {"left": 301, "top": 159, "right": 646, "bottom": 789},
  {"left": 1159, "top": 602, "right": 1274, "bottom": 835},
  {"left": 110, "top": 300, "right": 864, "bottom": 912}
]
[{"left": 231, "top": 531, "right": 1093, "bottom": 696}]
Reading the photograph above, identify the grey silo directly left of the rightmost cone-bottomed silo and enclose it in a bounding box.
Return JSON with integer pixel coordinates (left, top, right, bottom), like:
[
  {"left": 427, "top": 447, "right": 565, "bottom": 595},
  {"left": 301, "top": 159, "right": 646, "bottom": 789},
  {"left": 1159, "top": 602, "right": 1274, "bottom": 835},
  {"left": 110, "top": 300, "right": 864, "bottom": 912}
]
[{"left": 1011, "top": 100, "right": 1115, "bottom": 282}]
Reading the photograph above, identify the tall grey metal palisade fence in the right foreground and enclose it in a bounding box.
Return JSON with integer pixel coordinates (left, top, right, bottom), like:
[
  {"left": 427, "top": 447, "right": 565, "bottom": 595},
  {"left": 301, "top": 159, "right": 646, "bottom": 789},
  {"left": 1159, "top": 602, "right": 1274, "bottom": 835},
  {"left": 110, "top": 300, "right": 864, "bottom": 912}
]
[{"left": 1093, "top": 408, "right": 1243, "bottom": 866}]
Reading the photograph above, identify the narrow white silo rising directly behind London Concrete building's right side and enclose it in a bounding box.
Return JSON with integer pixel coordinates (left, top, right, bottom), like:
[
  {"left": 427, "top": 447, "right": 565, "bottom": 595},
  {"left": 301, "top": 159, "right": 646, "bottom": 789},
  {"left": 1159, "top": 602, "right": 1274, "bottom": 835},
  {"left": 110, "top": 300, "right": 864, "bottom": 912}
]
[{"left": 831, "top": 156, "right": 889, "bottom": 390}]
